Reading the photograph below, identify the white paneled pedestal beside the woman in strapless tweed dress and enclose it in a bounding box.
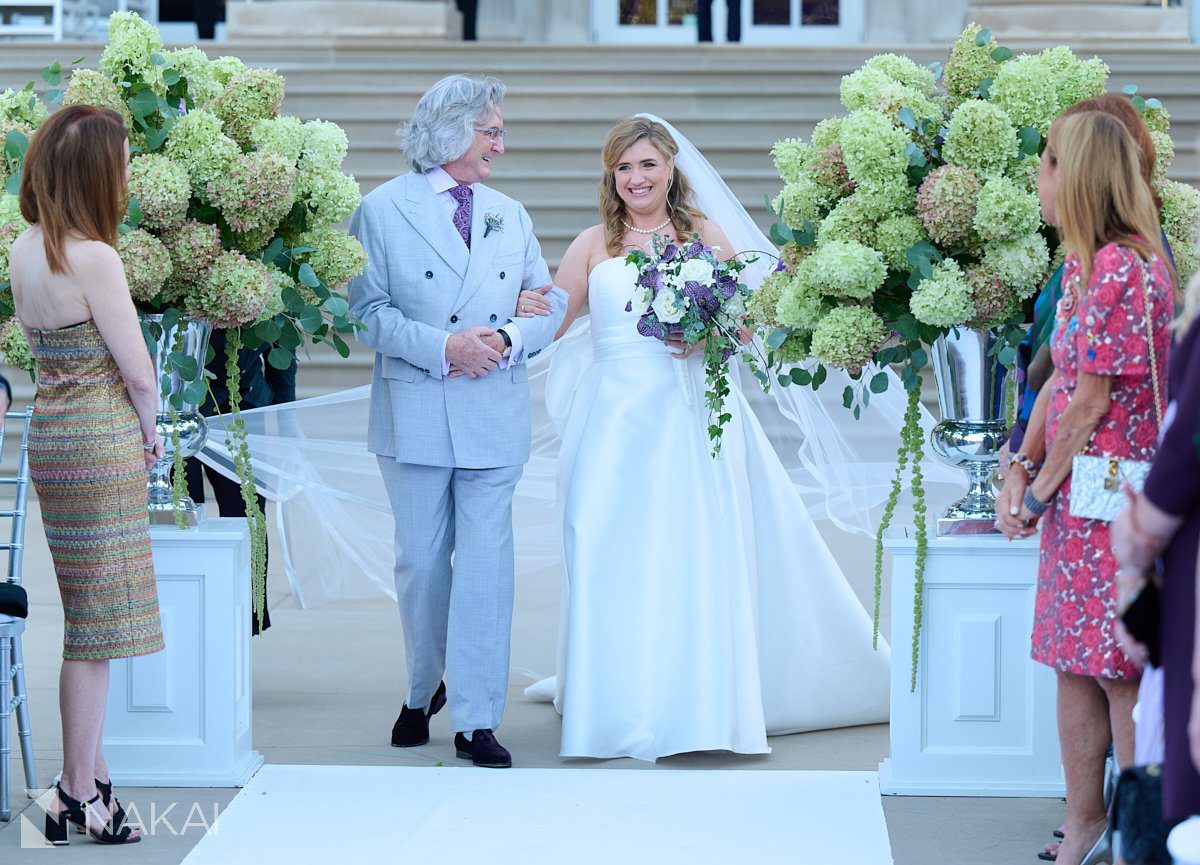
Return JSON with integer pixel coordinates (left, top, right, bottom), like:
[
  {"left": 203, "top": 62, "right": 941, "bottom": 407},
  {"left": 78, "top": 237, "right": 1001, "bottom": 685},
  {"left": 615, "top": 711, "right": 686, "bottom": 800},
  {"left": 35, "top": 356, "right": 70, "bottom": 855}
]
[{"left": 104, "top": 518, "right": 263, "bottom": 787}]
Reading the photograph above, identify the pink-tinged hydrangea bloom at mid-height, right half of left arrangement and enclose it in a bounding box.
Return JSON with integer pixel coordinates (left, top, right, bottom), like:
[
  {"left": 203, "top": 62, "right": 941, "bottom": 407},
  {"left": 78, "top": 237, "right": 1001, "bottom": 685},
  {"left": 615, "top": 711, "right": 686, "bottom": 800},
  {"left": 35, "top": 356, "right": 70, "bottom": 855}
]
[{"left": 209, "top": 150, "right": 296, "bottom": 233}]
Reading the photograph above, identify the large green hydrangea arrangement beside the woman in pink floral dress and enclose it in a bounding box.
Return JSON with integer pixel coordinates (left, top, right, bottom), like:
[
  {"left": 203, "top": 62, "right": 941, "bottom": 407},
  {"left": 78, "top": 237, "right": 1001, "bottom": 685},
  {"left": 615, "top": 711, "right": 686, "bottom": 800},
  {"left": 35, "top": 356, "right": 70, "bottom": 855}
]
[{"left": 750, "top": 24, "right": 1185, "bottom": 675}]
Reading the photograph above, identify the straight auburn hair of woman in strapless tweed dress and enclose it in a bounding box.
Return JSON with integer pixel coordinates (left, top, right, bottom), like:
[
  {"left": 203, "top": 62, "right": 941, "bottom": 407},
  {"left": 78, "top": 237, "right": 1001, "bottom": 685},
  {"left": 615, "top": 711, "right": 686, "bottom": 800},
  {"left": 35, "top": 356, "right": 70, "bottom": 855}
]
[{"left": 20, "top": 106, "right": 128, "bottom": 274}]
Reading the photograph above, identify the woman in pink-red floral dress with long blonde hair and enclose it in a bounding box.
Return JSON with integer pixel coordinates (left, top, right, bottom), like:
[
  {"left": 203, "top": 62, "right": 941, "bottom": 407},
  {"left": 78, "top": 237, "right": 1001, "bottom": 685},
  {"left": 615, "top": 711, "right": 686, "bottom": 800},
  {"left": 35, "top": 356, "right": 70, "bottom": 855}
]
[{"left": 996, "top": 112, "right": 1175, "bottom": 865}]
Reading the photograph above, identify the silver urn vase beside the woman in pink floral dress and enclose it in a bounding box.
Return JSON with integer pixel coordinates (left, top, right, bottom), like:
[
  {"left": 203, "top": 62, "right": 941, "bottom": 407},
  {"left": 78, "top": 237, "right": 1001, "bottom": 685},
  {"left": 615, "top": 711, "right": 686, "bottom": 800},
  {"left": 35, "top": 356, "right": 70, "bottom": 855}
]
[{"left": 930, "top": 328, "right": 1015, "bottom": 535}]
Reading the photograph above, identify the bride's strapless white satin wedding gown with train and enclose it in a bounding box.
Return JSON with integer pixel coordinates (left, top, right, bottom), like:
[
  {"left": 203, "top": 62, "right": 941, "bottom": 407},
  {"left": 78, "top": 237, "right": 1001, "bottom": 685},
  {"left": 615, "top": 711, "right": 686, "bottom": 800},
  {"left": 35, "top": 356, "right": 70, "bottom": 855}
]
[{"left": 530, "top": 258, "right": 889, "bottom": 761}]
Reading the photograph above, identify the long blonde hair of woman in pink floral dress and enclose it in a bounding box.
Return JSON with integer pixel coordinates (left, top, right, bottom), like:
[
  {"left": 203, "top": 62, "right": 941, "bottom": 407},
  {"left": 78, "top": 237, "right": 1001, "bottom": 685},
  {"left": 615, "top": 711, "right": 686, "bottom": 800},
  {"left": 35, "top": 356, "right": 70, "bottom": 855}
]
[{"left": 1046, "top": 112, "right": 1175, "bottom": 290}]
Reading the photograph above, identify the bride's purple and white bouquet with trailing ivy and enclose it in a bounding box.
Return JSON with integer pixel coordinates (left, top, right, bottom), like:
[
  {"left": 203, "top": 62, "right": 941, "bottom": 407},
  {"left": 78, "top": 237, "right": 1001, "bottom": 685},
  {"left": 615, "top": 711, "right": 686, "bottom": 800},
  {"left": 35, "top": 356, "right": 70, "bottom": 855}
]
[{"left": 625, "top": 235, "right": 750, "bottom": 457}]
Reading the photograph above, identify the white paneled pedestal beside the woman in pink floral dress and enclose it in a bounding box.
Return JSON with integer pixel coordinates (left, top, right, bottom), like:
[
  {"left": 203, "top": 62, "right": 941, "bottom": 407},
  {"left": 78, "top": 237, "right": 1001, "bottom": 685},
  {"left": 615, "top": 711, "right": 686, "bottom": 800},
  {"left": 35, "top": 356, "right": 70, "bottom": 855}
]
[{"left": 880, "top": 527, "right": 1063, "bottom": 797}]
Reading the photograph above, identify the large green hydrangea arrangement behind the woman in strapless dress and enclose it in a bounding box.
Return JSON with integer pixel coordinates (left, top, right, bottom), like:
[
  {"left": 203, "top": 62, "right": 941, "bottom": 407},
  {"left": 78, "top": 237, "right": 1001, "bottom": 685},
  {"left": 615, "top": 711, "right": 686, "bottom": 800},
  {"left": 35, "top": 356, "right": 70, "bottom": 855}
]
[{"left": 0, "top": 12, "right": 366, "bottom": 619}]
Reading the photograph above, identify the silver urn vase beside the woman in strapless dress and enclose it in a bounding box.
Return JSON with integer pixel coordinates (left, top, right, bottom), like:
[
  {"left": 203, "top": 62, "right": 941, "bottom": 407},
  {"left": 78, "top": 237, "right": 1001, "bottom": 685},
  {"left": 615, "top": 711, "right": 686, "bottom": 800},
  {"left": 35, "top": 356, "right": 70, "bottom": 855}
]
[{"left": 142, "top": 316, "right": 212, "bottom": 525}]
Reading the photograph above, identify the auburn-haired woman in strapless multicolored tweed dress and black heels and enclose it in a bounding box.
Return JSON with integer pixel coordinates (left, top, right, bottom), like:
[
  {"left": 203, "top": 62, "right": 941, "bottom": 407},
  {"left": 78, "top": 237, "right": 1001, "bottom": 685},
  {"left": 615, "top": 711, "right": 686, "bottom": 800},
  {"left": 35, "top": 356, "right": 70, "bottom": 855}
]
[{"left": 10, "top": 106, "right": 163, "bottom": 845}]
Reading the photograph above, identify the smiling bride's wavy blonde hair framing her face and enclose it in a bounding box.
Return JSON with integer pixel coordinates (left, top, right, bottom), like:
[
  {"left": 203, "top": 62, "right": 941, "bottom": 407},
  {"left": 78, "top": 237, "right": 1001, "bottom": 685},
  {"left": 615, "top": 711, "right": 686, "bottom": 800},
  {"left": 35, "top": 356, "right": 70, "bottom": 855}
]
[{"left": 600, "top": 118, "right": 704, "bottom": 256}]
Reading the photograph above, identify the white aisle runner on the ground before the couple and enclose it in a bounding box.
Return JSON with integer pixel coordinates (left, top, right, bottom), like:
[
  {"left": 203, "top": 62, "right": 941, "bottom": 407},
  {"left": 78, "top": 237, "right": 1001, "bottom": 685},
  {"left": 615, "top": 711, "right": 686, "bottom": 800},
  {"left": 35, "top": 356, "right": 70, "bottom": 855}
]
[{"left": 184, "top": 765, "right": 892, "bottom": 865}]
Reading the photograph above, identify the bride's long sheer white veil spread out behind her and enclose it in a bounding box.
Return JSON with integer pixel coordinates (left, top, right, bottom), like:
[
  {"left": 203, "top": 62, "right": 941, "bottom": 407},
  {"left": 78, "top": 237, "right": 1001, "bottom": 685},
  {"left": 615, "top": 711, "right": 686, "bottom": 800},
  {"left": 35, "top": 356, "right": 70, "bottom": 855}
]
[{"left": 199, "top": 114, "right": 961, "bottom": 607}]
